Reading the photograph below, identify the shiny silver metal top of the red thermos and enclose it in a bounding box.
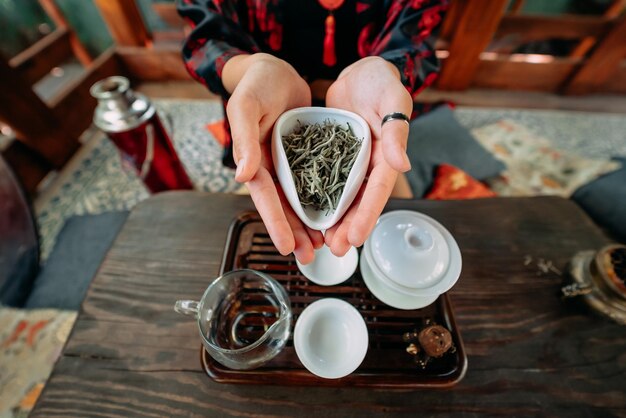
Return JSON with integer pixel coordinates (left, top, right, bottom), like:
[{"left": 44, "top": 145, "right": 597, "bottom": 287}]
[{"left": 89, "top": 76, "right": 155, "bottom": 133}]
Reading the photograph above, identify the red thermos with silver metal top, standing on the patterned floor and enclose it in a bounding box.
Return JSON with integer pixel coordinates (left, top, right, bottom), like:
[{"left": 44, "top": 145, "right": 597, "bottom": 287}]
[{"left": 90, "top": 76, "right": 193, "bottom": 193}]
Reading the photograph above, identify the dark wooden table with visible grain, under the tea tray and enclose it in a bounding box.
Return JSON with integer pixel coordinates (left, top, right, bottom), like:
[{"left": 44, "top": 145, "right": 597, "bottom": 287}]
[{"left": 32, "top": 192, "right": 626, "bottom": 417}]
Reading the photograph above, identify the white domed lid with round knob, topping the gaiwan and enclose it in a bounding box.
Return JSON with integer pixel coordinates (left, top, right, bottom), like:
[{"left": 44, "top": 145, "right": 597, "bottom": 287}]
[{"left": 365, "top": 210, "right": 461, "bottom": 294}]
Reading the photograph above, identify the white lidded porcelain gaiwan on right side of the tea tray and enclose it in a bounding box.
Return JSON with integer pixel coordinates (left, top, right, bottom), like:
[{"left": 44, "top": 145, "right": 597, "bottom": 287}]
[{"left": 361, "top": 210, "right": 462, "bottom": 309}]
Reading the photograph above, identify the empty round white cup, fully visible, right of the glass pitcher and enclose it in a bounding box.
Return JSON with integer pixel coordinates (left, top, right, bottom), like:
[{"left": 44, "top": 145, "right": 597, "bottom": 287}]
[{"left": 294, "top": 298, "right": 369, "bottom": 379}]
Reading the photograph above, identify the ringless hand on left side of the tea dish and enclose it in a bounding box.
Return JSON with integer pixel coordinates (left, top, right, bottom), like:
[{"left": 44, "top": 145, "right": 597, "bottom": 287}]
[{"left": 222, "top": 53, "right": 324, "bottom": 264}]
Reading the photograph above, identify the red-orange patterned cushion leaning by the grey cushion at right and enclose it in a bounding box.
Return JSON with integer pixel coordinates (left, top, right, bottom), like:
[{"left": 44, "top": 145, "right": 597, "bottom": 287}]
[{"left": 425, "top": 164, "right": 496, "bottom": 200}]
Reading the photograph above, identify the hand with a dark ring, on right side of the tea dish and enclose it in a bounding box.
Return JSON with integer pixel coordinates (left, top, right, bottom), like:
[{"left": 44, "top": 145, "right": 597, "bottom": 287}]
[{"left": 325, "top": 57, "right": 413, "bottom": 256}]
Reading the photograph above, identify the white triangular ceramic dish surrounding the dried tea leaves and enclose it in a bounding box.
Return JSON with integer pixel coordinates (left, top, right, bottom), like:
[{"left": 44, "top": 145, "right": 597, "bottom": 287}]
[{"left": 272, "top": 107, "right": 372, "bottom": 231}]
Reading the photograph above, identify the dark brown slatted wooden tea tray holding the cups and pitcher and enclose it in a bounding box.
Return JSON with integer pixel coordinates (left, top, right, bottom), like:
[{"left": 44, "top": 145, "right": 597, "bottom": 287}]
[{"left": 201, "top": 212, "right": 467, "bottom": 388}]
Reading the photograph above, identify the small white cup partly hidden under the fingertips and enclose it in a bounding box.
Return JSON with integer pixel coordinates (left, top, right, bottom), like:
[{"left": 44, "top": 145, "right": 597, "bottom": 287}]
[{"left": 296, "top": 245, "right": 359, "bottom": 286}]
